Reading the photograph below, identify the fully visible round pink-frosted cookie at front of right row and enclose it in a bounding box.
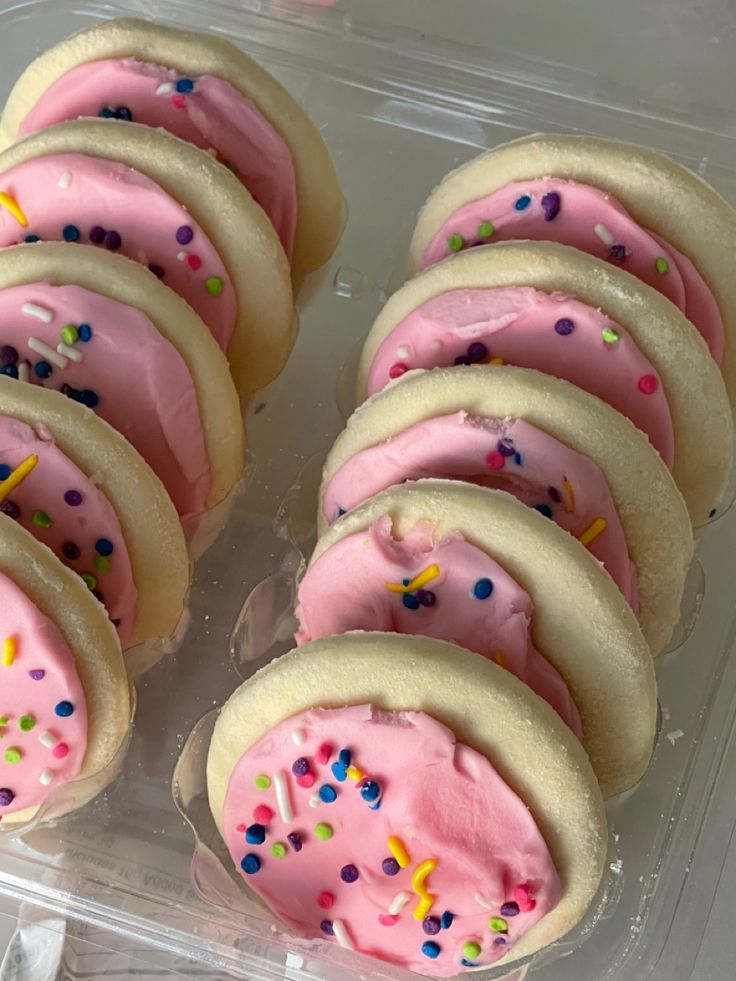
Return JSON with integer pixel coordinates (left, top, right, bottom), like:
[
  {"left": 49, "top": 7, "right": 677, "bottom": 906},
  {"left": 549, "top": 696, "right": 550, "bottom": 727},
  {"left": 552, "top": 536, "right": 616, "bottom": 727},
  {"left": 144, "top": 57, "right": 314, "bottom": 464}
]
[{"left": 207, "top": 633, "right": 606, "bottom": 976}]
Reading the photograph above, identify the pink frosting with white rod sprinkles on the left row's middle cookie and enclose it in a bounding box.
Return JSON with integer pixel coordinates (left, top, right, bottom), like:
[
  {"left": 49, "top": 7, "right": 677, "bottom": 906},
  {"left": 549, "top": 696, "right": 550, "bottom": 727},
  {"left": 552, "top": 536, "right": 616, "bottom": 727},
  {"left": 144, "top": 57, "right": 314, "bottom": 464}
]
[{"left": 0, "top": 283, "right": 212, "bottom": 518}]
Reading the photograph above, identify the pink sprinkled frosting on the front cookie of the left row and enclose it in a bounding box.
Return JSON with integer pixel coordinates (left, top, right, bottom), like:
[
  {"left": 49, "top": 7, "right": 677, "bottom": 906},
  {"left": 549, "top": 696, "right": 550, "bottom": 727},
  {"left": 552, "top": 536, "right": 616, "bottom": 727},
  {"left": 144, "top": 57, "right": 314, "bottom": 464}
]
[{"left": 0, "top": 573, "right": 87, "bottom": 819}]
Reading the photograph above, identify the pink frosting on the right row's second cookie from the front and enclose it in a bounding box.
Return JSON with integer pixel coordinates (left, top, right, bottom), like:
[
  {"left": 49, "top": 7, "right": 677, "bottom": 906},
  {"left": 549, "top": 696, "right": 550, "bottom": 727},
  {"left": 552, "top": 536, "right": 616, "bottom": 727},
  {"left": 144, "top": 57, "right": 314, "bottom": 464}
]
[{"left": 296, "top": 515, "right": 582, "bottom": 738}]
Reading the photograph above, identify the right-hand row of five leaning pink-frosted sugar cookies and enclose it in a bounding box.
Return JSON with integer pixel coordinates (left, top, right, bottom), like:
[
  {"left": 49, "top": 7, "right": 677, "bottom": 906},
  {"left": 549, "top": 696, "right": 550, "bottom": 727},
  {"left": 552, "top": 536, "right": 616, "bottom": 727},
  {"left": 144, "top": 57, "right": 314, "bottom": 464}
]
[{"left": 208, "top": 136, "right": 736, "bottom": 976}]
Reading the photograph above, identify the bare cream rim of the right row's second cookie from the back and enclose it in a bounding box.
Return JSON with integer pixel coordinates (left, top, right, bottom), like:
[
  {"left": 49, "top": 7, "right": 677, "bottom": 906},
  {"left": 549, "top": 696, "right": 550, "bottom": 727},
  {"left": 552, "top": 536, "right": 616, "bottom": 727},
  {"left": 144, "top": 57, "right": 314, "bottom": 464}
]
[{"left": 357, "top": 242, "right": 733, "bottom": 525}]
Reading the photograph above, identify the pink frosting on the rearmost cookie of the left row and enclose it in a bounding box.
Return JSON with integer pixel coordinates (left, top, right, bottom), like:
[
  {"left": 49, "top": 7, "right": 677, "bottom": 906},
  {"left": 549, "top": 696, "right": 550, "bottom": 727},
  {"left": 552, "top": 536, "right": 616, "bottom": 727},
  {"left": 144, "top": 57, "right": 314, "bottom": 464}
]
[{"left": 18, "top": 58, "right": 297, "bottom": 256}]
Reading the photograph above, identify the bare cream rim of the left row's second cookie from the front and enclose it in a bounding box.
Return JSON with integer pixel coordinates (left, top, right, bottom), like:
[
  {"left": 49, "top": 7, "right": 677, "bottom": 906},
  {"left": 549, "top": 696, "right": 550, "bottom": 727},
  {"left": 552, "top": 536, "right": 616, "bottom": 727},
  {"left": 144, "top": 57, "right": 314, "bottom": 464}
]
[{"left": 0, "top": 377, "right": 190, "bottom": 660}]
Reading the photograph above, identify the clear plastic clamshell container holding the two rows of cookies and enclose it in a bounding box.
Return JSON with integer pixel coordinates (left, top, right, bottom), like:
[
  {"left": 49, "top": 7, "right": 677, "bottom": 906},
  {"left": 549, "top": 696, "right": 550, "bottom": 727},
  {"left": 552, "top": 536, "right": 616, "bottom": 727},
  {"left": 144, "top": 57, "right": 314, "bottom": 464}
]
[{"left": 0, "top": 0, "right": 736, "bottom": 981}]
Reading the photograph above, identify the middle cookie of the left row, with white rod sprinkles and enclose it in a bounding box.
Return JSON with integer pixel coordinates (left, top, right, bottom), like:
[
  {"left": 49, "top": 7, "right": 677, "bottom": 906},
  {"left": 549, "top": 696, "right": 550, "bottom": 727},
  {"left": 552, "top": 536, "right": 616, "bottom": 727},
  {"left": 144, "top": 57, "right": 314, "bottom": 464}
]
[{"left": 0, "top": 242, "right": 245, "bottom": 518}]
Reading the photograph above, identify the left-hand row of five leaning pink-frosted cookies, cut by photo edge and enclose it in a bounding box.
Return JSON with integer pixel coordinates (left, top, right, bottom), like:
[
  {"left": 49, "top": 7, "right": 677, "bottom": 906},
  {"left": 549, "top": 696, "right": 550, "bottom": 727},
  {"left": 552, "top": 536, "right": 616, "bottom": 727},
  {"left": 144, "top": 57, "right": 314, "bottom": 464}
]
[{"left": 0, "top": 20, "right": 342, "bottom": 826}]
